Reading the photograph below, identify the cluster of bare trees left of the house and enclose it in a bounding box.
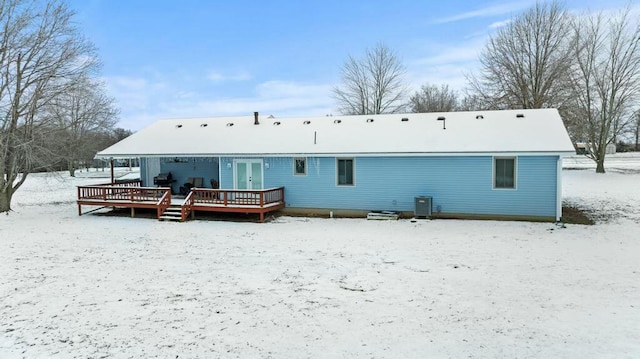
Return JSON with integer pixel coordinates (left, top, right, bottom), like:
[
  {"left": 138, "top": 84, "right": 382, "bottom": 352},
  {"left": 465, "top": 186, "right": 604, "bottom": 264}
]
[{"left": 0, "top": 0, "right": 122, "bottom": 212}]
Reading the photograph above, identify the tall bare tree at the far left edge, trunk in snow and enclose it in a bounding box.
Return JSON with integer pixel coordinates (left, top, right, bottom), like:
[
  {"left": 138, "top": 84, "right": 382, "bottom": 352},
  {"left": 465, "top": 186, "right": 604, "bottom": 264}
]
[{"left": 0, "top": 0, "right": 96, "bottom": 212}]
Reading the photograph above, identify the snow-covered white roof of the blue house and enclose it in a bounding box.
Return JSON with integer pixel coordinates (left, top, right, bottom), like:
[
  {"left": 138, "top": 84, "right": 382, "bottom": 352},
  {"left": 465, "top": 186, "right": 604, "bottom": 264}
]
[{"left": 96, "top": 109, "right": 574, "bottom": 158}]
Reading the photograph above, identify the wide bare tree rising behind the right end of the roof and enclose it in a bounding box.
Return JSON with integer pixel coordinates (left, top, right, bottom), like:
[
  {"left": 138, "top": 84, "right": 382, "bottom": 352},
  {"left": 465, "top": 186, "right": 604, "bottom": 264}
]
[{"left": 468, "top": 1, "right": 572, "bottom": 109}]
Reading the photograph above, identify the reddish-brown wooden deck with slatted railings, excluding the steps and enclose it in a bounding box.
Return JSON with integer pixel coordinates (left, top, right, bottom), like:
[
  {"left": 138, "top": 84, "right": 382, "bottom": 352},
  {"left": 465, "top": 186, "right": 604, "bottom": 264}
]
[{"left": 77, "top": 181, "right": 285, "bottom": 222}]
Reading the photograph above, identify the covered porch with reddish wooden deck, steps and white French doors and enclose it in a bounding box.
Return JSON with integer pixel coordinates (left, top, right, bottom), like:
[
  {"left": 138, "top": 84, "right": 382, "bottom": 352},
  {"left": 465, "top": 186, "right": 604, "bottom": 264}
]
[{"left": 86, "top": 143, "right": 285, "bottom": 222}]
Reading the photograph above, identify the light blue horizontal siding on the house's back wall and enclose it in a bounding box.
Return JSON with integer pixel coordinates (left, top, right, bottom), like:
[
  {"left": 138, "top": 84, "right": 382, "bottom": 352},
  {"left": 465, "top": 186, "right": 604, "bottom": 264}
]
[{"left": 236, "top": 156, "right": 557, "bottom": 216}]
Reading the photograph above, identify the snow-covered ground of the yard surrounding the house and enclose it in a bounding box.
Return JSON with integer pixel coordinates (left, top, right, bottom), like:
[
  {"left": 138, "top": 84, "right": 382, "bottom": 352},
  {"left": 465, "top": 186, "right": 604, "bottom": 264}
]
[{"left": 0, "top": 155, "right": 640, "bottom": 358}]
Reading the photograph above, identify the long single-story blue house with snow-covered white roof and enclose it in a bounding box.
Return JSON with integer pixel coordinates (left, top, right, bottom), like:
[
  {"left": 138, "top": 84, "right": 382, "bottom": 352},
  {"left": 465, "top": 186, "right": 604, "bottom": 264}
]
[{"left": 78, "top": 109, "right": 575, "bottom": 221}]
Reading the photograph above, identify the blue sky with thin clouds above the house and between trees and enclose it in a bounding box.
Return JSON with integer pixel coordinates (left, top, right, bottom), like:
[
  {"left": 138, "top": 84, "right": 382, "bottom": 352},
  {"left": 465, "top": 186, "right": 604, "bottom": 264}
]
[{"left": 69, "top": 0, "right": 637, "bottom": 131}]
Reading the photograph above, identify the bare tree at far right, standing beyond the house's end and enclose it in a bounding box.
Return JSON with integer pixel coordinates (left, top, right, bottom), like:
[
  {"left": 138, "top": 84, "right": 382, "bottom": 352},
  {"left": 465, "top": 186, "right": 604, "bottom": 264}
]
[{"left": 571, "top": 8, "right": 640, "bottom": 173}]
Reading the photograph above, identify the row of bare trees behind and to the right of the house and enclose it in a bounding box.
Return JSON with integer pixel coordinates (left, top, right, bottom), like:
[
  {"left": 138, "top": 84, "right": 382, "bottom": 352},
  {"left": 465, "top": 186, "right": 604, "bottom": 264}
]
[{"left": 333, "top": 1, "right": 640, "bottom": 173}]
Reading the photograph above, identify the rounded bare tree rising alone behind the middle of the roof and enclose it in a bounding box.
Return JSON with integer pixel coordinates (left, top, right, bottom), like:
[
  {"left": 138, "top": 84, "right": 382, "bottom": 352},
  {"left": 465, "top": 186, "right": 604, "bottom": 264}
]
[{"left": 333, "top": 44, "right": 405, "bottom": 115}]
